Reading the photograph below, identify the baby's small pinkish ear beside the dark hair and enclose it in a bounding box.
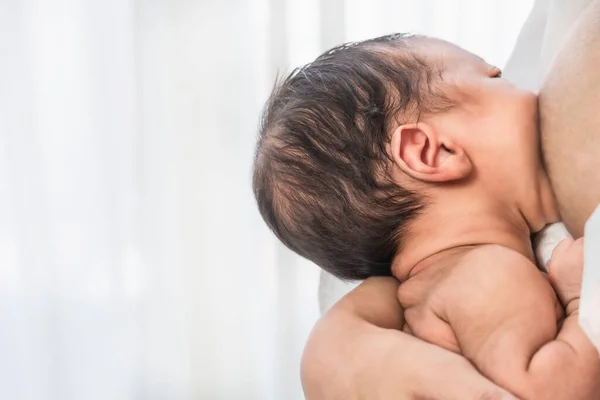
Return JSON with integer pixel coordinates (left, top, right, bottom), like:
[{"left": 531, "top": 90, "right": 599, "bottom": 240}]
[{"left": 391, "top": 122, "right": 473, "bottom": 182}]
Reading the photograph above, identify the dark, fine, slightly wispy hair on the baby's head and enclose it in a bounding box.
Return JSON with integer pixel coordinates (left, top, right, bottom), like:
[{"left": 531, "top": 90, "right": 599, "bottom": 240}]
[{"left": 253, "top": 34, "right": 451, "bottom": 279}]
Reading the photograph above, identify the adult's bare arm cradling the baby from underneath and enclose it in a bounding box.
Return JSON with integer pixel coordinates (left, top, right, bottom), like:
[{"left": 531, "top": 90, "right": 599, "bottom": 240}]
[{"left": 302, "top": 278, "right": 514, "bottom": 400}]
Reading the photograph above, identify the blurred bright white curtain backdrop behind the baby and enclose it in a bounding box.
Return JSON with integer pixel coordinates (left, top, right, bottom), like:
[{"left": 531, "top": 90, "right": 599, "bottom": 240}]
[{"left": 0, "top": 0, "right": 532, "bottom": 400}]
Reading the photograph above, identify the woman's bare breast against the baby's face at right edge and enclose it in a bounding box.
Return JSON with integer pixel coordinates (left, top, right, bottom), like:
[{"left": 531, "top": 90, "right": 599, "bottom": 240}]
[{"left": 539, "top": 0, "right": 600, "bottom": 237}]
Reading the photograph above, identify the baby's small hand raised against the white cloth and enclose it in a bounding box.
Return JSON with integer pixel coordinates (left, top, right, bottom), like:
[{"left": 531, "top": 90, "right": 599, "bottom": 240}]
[{"left": 548, "top": 238, "right": 583, "bottom": 315}]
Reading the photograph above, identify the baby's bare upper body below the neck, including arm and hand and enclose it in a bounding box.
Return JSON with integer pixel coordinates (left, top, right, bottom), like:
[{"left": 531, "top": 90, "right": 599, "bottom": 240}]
[{"left": 398, "top": 240, "right": 600, "bottom": 400}]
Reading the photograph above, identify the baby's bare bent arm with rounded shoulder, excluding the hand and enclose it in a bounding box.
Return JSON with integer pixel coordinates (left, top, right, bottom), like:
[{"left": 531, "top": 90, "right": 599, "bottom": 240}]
[{"left": 446, "top": 247, "right": 600, "bottom": 400}]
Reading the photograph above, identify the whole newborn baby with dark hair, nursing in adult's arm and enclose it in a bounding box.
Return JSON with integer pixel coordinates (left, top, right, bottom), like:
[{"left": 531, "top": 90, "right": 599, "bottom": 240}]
[{"left": 253, "top": 34, "right": 600, "bottom": 400}]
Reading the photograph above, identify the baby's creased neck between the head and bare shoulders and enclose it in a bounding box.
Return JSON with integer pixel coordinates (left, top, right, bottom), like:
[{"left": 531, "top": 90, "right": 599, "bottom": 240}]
[{"left": 392, "top": 169, "right": 559, "bottom": 280}]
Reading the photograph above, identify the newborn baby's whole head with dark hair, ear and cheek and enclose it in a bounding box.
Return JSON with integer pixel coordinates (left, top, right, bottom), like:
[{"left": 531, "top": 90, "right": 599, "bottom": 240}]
[{"left": 253, "top": 34, "right": 541, "bottom": 279}]
